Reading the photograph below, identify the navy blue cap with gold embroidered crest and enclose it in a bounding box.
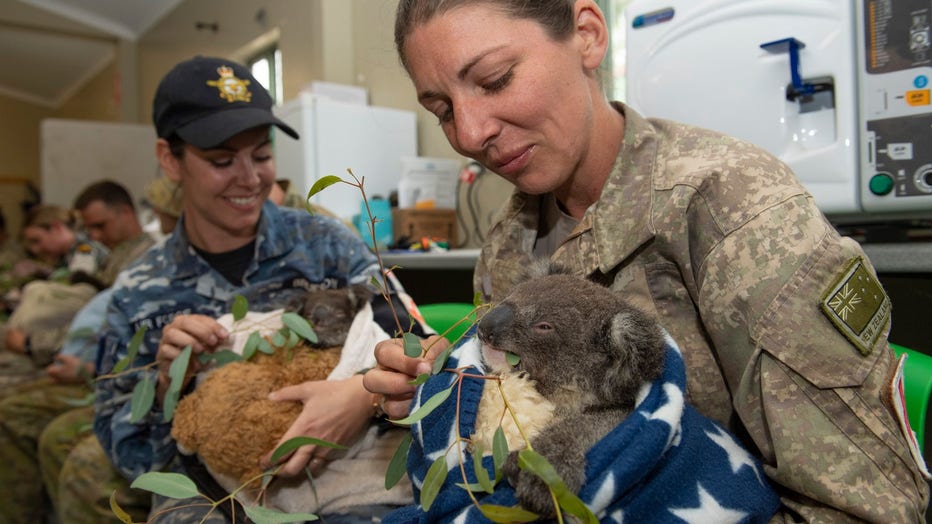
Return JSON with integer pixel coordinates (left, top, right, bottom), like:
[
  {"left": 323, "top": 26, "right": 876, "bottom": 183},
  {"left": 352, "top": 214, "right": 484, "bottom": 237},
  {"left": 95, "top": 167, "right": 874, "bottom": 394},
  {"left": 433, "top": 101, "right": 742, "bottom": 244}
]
[{"left": 152, "top": 56, "right": 298, "bottom": 149}]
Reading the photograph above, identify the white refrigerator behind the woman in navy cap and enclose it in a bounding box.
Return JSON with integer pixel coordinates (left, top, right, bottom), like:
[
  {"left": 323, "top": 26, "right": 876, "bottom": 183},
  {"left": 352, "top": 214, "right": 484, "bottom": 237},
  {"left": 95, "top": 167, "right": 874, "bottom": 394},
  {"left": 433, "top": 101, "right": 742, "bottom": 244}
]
[{"left": 275, "top": 93, "right": 417, "bottom": 219}]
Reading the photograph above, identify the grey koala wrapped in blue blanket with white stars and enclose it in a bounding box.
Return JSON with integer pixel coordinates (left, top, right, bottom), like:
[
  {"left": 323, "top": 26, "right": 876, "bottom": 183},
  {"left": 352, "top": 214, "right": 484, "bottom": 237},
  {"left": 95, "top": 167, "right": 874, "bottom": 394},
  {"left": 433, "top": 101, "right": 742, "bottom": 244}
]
[{"left": 478, "top": 275, "right": 664, "bottom": 517}]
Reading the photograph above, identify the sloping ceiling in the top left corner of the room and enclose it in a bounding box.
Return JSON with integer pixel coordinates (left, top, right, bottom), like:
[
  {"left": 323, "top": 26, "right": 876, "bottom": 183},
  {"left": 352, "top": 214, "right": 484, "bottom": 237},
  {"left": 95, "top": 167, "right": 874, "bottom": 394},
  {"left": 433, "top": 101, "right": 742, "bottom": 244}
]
[{"left": 0, "top": 0, "right": 183, "bottom": 108}]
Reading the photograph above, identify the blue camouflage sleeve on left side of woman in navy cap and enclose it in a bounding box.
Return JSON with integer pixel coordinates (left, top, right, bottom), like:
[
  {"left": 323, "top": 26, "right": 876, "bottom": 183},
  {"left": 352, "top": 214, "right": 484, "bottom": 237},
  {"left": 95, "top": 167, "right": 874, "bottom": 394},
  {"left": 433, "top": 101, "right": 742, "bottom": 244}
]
[{"left": 94, "top": 297, "right": 175, "bottom": 479}]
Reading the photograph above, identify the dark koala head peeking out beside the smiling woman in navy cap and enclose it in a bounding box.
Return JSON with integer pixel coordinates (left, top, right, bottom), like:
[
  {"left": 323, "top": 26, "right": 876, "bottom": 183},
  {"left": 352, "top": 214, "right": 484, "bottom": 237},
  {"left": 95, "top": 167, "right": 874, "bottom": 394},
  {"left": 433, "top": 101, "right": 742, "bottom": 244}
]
[{"left": 297, "top": 284, "right": 374, "bottom": 348}]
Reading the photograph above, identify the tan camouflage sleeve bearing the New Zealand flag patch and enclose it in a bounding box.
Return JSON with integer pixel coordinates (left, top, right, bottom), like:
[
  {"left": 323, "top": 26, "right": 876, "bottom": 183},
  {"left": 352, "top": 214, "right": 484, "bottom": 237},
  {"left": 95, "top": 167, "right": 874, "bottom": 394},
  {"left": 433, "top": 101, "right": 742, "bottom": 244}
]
[{"left": 697, "top": 197, "right": 928, "bottom": 522}]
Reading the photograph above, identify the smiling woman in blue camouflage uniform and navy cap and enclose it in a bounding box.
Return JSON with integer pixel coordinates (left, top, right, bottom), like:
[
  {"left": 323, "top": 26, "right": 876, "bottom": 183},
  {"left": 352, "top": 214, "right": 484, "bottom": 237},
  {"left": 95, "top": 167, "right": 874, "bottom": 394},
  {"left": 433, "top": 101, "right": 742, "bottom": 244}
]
[{"left": 94, "top": 57, "right": 410, "bottom": 522}]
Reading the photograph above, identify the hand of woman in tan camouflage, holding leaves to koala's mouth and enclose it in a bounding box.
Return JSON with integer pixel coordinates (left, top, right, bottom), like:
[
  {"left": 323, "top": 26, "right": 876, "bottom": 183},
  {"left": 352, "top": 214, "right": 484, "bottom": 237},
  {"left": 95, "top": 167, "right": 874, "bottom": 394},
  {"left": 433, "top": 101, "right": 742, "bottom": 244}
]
[{"left": 363, "top": 335, "right": 450, "bottom": 419}]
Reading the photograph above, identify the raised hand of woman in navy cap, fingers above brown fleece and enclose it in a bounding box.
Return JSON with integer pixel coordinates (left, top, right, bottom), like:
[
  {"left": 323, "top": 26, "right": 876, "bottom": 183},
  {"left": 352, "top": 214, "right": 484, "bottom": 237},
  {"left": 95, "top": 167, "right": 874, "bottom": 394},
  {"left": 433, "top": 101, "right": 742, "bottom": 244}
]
[{"left": 155, "top": 315, "right": 230, "bottom": 403}]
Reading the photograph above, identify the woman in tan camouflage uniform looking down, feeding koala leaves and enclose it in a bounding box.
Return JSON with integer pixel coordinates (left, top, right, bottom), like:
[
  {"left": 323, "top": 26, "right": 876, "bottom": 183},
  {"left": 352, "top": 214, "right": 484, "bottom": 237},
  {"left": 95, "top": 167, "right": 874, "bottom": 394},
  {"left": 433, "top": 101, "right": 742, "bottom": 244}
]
[{"left": 365, "top": 0, "right": 929, "bottom": 523}]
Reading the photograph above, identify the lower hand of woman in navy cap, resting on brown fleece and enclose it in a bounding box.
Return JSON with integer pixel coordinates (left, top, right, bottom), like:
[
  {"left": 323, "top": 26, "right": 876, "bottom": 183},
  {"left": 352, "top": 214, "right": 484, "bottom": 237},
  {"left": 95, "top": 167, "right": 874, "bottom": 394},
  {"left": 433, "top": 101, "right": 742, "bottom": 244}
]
[{"left": 260, "top": 375, "right": 375, "bottom": 477}]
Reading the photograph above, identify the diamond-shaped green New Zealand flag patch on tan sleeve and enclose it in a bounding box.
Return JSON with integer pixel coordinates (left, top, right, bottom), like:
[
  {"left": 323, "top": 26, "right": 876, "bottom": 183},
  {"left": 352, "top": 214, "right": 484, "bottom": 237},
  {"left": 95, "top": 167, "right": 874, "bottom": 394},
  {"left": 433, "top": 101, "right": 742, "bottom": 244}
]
[{"left": 822, "top": 257, "right": 891, "bottom": 355}]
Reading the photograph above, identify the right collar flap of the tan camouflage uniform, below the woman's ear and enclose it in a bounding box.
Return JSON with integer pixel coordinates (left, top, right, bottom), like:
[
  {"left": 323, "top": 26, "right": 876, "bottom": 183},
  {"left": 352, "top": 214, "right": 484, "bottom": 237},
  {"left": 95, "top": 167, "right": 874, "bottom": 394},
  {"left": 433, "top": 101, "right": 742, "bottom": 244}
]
[{"left": 580, "top": 102, "right": 657, "bottom": 273}]
